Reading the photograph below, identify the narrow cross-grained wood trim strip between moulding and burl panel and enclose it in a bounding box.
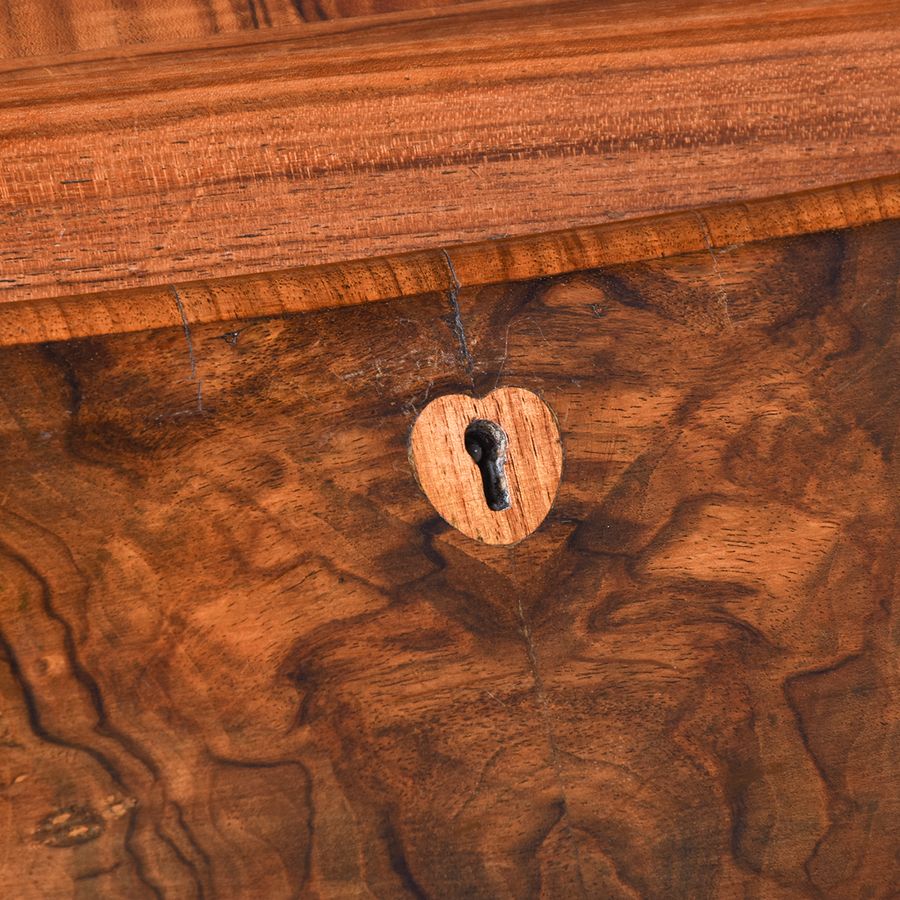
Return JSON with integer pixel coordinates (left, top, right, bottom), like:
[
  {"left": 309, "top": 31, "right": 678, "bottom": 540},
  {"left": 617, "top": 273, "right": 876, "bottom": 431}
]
[{"left": 0, "top": 175, "right": 900, "bottom": 346}]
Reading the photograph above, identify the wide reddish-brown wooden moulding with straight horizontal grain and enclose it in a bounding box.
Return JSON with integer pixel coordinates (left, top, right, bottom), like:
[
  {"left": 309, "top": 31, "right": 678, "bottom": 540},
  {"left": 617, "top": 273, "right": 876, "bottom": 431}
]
[{"left": 0, "top": 0, "right": 900, "bottom": 301}]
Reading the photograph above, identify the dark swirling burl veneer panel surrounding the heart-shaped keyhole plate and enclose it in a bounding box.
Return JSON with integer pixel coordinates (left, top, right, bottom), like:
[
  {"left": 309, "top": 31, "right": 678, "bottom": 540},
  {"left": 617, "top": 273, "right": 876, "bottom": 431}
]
[{"left": 0, "top": 214, "right": 900, "bottom": 900}]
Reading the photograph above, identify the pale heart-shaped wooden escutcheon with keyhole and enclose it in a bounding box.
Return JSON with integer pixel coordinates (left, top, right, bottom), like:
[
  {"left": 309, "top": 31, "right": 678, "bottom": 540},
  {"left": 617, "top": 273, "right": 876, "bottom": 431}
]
[{"left": 409, "top": 387, "right": 562, "bottom": 544}]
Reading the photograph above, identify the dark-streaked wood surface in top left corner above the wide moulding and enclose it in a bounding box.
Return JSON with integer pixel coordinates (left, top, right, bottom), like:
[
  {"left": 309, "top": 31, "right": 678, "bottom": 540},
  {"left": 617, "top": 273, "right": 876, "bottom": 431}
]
[{"left": 0, "top": 0, "right": 478, "bottom": 59}]
